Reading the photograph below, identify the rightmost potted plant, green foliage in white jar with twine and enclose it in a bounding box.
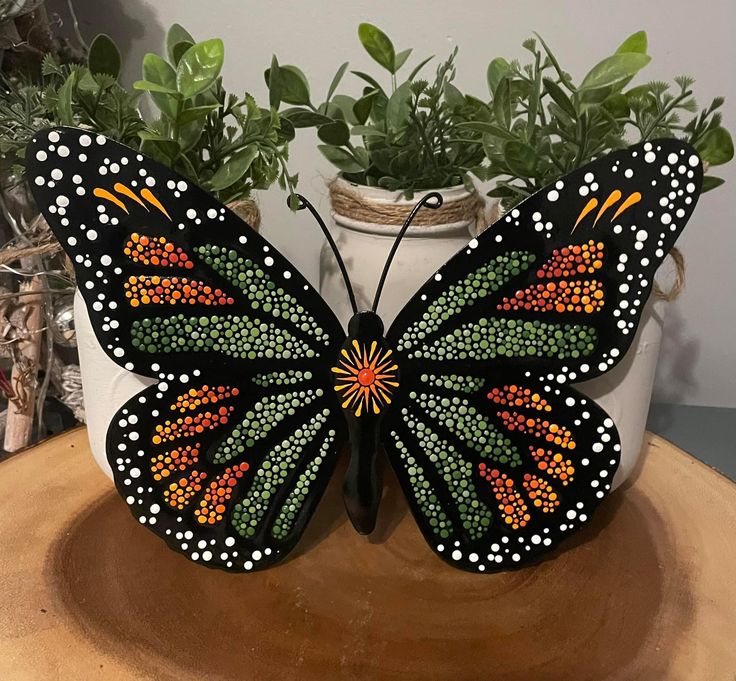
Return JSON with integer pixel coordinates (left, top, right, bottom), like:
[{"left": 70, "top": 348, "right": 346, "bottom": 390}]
[{"left": 462, "top": 31, "right": 733, "bottom": 484}]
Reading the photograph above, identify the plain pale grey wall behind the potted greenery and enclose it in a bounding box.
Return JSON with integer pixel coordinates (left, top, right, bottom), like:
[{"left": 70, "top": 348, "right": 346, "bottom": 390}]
[{"left": 49, "top": 0, "right": 736, "bottom": 407}]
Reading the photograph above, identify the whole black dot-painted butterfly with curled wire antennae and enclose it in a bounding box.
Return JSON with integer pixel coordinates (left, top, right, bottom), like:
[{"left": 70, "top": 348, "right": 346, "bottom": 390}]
[{"left": 28, "top": 128, "right": 702, "bottom": 572}]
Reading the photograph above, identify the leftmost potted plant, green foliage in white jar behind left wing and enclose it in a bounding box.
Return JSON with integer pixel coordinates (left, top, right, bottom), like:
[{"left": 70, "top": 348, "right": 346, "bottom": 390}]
[{"left": 0, "top": 24, "right": 296, "bottom": 456}]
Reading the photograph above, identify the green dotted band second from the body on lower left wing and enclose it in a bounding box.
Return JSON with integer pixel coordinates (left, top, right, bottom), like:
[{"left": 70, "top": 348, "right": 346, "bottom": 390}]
[{"left": 232, "top": 409, "right": 330, "bottom": 538}]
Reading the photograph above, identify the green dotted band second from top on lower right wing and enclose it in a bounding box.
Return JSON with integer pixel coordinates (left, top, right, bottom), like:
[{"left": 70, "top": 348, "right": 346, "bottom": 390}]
[{"left": 409, "top": 392, "right": 522, "bottom": 467}]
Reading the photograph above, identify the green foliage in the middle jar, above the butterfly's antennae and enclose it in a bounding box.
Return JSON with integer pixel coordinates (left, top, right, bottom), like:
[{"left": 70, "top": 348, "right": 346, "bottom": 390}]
[{"left": 265, "top": 24, "right": 484, "bottom": 197}]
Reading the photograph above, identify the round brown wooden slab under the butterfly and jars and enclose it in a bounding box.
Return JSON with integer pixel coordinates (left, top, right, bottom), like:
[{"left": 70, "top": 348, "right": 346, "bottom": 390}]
[{"left": 0, "top": 429, "right": 736, "bottom": 681}]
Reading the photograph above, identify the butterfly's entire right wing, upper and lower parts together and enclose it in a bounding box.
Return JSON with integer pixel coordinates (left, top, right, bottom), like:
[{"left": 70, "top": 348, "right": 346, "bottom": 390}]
[{"left": 383, "top": 140, "right": 702, "bottom": 571}]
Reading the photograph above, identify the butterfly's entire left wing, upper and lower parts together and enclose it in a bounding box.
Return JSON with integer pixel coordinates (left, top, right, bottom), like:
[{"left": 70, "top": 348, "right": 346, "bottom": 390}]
[{"left": 28, "top": 128, "right": 345, "bottom": 570}]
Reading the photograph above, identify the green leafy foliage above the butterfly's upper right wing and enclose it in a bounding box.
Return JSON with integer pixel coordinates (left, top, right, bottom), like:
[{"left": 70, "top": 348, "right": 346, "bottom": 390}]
[{"left": 474, "top": 31, "right": 733, "bottom": 207}]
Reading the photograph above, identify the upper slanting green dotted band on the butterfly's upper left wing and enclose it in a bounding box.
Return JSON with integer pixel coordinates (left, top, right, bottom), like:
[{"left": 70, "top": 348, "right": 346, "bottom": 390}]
[{"left": 194, "top": 244, "right": 330, "bottom": 345}]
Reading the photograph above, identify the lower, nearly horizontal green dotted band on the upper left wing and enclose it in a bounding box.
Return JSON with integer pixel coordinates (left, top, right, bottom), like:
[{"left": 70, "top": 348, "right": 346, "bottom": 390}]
[{"left": 130, "top": 314, "right": 318, "bottom": 360}]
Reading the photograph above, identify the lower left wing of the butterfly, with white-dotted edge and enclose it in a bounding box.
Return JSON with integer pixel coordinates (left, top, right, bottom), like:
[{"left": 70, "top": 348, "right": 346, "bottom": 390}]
[{"left": 107, "top": 369, "right": 344, "bottom": 571}]
